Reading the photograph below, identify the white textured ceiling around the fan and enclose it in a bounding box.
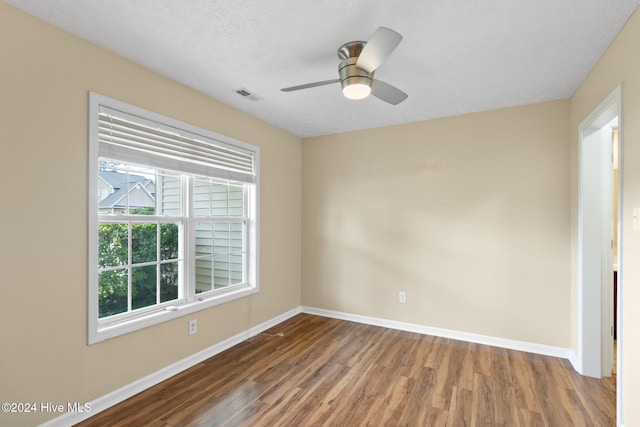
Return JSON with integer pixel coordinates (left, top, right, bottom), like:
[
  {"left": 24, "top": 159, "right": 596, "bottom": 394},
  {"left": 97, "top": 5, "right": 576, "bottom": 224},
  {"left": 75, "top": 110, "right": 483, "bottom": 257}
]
[{"left": 5, "top": 0, "right": 640, "bottom": 137}]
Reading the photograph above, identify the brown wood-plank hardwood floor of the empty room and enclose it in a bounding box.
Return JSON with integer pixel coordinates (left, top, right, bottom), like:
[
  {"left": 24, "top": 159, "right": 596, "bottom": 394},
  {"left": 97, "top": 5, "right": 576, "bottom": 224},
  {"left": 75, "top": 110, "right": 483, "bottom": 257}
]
[{"left": 78, "top": 314, "right": 616, "bottom": 427}]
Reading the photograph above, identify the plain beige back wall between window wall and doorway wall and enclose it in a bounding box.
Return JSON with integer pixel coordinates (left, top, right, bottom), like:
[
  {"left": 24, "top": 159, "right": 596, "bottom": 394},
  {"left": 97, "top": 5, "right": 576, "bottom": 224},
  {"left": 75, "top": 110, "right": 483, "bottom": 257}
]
[{"left": 302, "top": 100, "right": 571, "bottom": 348}]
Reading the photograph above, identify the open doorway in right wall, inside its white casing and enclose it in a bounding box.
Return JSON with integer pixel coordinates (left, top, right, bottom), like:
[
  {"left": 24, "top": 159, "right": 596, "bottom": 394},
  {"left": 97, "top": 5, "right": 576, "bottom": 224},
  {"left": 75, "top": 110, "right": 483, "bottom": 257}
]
[{"left": 578, "top": 87, "right": 622, "bottom": 382}]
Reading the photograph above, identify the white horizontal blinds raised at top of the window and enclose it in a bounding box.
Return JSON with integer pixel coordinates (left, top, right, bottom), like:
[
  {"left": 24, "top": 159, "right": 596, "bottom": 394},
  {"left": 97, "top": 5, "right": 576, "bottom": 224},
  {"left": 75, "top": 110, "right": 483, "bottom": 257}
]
[{"left": 98, "top": 106, "right": 255, "bottom": 183}]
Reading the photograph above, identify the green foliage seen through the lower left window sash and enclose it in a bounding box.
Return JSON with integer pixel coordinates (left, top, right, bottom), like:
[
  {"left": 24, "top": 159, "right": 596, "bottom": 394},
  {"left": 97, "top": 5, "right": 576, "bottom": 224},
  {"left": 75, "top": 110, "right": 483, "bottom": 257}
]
[{"left": 98, "top": 223, "right": 178, "bottom": 318}]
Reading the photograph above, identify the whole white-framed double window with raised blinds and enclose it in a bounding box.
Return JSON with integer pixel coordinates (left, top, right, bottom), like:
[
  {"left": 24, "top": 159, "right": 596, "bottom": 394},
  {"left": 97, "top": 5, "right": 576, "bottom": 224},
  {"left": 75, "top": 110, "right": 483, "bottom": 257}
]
[{"left": 88, "top": 93, "right": 259, "bottom": 343}]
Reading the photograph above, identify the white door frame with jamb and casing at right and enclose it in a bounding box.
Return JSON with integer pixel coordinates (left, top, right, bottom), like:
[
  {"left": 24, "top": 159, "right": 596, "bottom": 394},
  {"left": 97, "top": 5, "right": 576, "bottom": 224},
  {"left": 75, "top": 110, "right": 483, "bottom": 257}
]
[{"left": 578, "top": 86, "right": 623, "bottom": 421}]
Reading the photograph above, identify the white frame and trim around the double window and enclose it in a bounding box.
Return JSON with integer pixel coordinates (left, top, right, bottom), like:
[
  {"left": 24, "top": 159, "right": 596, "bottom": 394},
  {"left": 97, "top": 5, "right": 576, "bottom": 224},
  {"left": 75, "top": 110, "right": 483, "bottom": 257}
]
[{"left": 87, "top": 92, "right": 260, "bottom": 344}]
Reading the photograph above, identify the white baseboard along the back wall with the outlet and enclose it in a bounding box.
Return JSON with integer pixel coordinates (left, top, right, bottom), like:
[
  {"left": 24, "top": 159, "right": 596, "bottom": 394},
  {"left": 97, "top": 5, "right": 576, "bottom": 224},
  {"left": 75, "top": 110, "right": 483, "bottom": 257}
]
[{"left": 302, "top": 306, "right": 575, "bottom": 362}]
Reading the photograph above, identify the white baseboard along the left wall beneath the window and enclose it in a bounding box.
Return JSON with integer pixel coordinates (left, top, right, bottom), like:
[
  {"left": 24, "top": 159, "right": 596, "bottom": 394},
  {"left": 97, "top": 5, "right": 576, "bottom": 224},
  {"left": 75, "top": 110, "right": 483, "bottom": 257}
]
[{"left": 40, "top": 307, "right": 301, "bottom": 427}]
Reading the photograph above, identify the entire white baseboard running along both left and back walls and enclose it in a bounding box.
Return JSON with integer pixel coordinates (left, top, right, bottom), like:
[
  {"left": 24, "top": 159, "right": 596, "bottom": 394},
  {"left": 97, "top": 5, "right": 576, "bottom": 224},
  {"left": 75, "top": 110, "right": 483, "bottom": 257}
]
[{"left": 41, "top": 306, "right": 580, "bottom": 427}]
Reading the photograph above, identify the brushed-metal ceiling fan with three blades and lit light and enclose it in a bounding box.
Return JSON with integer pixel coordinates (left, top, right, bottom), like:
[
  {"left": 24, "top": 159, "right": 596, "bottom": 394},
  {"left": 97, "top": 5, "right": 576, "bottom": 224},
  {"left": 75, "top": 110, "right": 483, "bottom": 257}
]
[{"left": 281, "top": 27, "right": 408, "bottom": 105}]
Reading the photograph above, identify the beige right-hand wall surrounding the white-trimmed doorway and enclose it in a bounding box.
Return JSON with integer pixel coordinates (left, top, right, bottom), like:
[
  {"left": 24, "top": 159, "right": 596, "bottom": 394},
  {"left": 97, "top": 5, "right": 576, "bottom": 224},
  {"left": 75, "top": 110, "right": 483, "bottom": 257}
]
[{"left": 571, "top": 5, "right": 640, "bottom": 426}]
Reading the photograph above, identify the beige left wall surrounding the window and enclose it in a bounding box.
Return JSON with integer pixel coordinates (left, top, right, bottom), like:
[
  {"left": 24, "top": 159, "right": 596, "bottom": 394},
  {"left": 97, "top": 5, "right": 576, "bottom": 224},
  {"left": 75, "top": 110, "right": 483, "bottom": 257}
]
[{"left": 0, "top": 2, "right": 302, "bottom": 426}]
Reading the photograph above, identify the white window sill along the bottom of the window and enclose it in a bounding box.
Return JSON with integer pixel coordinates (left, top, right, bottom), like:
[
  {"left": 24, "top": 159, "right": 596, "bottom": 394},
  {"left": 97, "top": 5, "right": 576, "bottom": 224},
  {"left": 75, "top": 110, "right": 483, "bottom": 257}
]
[{"left": 88, "top": 285, "right": 258, "bottom": 345}]
